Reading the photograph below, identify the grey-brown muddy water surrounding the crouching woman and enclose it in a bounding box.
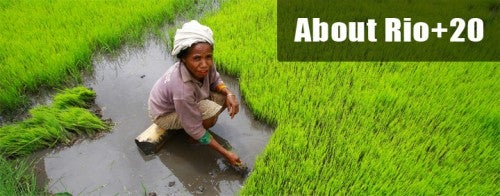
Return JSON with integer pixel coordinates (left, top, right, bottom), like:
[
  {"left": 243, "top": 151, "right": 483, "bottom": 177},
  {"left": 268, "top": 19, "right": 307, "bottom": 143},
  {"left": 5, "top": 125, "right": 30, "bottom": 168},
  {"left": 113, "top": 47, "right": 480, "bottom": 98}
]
[{"left": 36, "top": 39, "right": 272, "bottom": 195}]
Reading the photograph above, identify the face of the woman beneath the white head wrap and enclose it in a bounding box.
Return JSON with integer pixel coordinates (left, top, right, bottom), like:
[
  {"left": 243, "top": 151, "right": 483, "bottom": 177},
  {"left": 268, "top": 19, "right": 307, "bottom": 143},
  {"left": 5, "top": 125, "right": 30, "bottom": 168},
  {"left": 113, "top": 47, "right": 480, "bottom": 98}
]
[{"left": 182, "top": 43, "right": 214, "bottom": 80}]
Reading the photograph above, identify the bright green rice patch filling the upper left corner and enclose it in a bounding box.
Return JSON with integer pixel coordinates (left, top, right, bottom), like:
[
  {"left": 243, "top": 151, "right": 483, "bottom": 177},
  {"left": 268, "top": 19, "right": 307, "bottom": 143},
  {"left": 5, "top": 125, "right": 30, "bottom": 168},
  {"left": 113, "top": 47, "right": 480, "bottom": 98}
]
[{"left": 0, "top": 0, "right": 198, "bottom": 117}]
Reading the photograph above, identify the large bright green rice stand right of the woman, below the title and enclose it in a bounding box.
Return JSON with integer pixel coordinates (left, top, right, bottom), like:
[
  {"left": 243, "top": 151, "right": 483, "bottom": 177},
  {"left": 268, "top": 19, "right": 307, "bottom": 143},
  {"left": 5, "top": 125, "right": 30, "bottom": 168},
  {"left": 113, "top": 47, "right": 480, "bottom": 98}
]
[{"left": 203, "top": 0, "right": 500, "bottom": 195}]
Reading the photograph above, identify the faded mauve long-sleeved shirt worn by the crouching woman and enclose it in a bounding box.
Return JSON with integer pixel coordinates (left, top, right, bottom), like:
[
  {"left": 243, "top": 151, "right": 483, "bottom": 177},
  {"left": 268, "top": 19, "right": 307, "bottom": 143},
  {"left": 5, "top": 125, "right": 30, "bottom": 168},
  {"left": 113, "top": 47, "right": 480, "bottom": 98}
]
[{"left": 148, "top": 62, "right": 223, "bottom": 140}]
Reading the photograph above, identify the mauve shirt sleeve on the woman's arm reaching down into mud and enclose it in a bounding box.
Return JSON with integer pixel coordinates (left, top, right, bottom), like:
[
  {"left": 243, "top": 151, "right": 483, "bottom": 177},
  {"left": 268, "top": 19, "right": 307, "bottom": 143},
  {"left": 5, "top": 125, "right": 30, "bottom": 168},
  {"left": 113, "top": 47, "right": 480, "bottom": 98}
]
[{"left": 174, "top": 97, "right": 206, "bottom": 140}]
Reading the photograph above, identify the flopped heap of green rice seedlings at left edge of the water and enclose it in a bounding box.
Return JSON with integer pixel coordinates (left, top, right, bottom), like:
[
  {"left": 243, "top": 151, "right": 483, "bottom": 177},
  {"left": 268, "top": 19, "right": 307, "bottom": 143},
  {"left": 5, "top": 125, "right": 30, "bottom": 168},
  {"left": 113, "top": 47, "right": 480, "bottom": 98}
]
[{"left": 0, "top": 86, "right": 109, "bottom": 157}]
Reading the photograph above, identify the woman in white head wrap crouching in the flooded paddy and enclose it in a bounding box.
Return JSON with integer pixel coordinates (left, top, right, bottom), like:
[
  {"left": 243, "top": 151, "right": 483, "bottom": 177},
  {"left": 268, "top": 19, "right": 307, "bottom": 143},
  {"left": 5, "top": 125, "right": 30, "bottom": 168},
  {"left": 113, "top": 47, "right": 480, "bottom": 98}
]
[{"left": 148, "top": 20, "right": 241, "bottom": 165}]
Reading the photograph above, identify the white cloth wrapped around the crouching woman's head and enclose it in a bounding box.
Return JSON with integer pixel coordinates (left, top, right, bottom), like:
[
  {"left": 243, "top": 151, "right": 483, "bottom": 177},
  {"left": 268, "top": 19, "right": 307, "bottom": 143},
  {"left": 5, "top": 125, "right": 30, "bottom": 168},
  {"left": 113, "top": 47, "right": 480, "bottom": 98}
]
[{"left": 172, "top": 20, "right": 214, "bottom": 56}]
